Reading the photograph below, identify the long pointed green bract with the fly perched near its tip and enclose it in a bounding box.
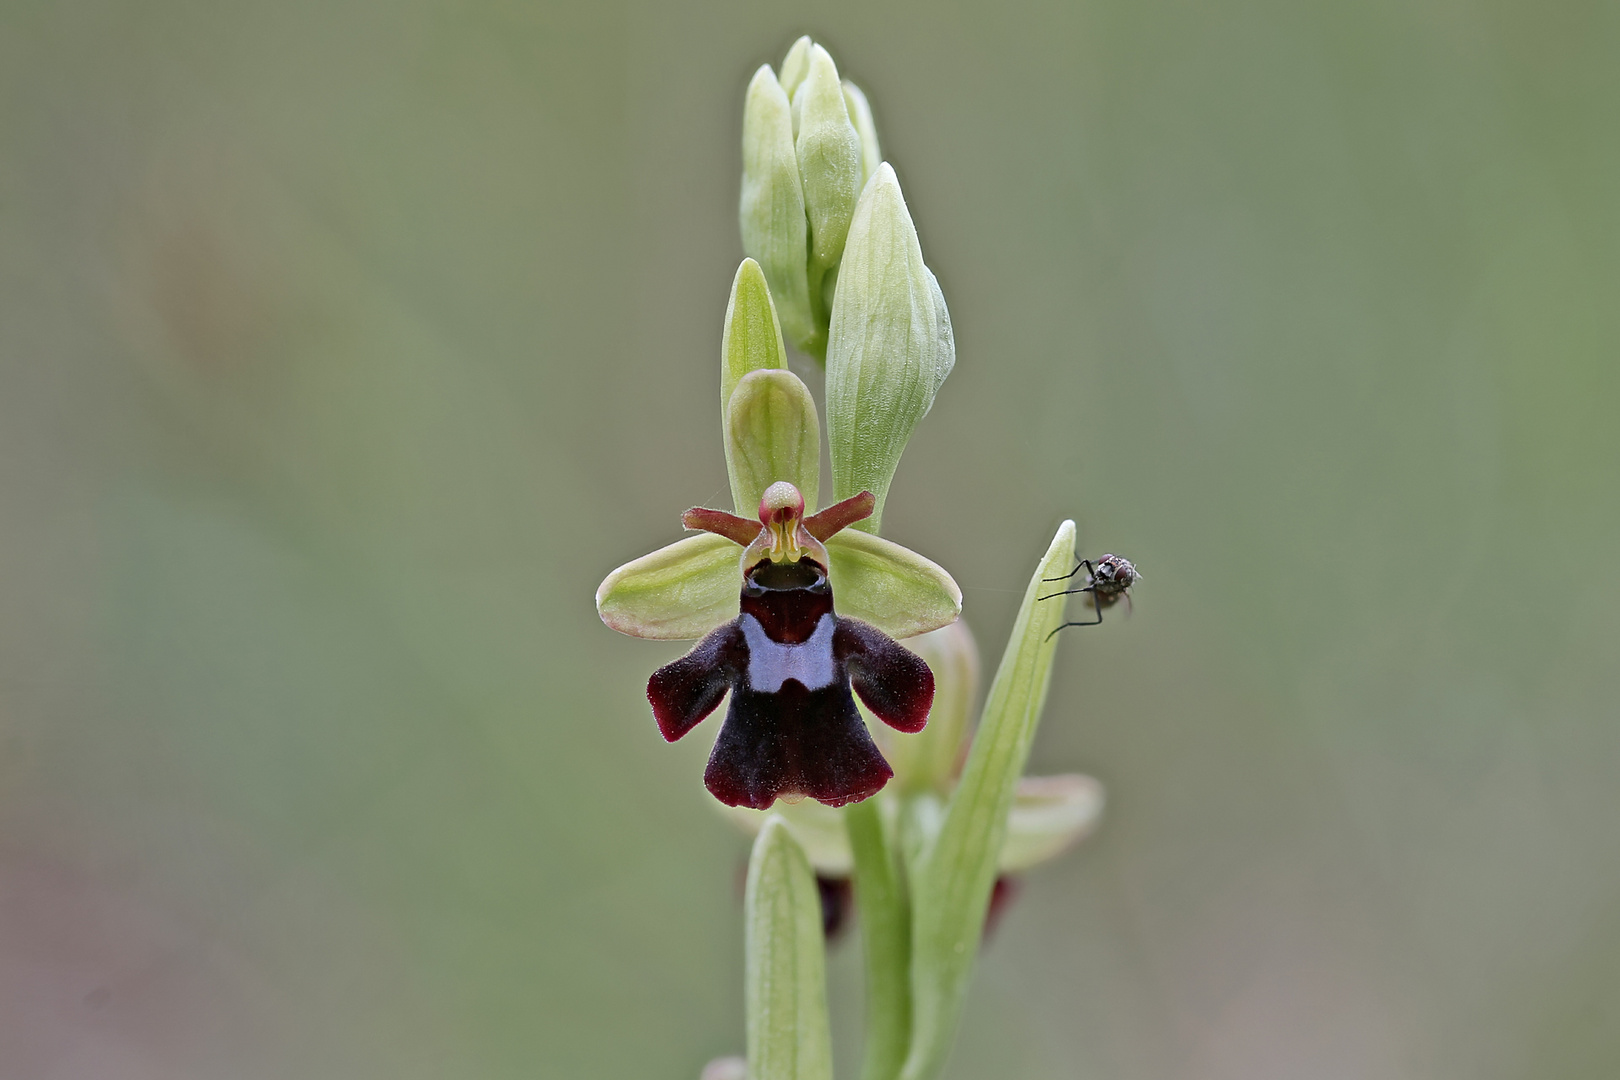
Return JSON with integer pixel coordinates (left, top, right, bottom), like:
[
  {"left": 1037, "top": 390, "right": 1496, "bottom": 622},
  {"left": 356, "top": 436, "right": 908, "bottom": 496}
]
[{"left": 901, "top": 521, "right": 1074, "bottom": 1080}]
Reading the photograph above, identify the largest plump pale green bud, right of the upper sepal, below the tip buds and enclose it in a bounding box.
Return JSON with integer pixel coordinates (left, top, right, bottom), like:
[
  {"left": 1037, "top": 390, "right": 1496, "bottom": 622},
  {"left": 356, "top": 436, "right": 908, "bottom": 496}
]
[{"left": 826, "top": 162, "right": 956, "bottom": 533}]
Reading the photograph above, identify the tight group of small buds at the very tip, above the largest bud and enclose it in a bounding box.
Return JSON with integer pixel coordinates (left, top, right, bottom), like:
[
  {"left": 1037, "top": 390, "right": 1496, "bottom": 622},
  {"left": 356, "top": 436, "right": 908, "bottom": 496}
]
[{"left": 739, "top": 37, "right": 883, "bottom": 359}]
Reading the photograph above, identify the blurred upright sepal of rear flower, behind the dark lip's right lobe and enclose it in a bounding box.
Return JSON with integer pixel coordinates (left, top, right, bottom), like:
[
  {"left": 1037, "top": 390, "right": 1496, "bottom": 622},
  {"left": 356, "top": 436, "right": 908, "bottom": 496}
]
[{"left": 872, "top": 619, "right": 978, "bottom": 795}]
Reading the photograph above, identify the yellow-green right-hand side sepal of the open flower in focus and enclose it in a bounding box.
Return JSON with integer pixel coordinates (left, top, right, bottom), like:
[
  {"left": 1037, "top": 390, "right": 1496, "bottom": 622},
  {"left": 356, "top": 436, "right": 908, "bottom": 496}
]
[{"left": 826, "top": 528, "right": 962, "bottom": 638}]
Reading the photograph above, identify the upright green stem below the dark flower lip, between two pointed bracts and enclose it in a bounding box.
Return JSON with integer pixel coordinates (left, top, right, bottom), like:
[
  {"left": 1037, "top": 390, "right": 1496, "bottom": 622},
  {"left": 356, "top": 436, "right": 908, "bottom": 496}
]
[{"left": 844, "top": 798, "right": 912, "bottom": 1080}]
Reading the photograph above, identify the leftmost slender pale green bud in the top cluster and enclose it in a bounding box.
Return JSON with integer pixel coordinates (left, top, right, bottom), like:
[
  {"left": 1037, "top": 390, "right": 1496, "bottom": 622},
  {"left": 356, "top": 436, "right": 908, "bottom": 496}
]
[{"left": 737, "top": 65, "right": 825, "bottom": 350}]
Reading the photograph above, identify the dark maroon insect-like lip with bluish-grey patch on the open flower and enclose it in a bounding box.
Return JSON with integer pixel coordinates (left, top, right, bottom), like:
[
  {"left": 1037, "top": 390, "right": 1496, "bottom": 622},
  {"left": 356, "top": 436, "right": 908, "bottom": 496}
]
[{"left": 646, "top": 559, "right": 933, "bottom": 810}]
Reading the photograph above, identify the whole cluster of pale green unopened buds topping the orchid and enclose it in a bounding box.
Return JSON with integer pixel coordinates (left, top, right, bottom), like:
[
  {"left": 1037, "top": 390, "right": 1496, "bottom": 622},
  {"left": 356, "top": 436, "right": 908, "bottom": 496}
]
[{"left": 740, "top": 37, "right": 956, "bottom": 533}]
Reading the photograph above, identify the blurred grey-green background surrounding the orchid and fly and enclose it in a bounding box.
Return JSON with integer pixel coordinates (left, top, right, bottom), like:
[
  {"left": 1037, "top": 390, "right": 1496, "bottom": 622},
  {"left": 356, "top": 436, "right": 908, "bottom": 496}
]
[{"left": 0, "top": 0, "right": 1620, "bottom": 1080}]
